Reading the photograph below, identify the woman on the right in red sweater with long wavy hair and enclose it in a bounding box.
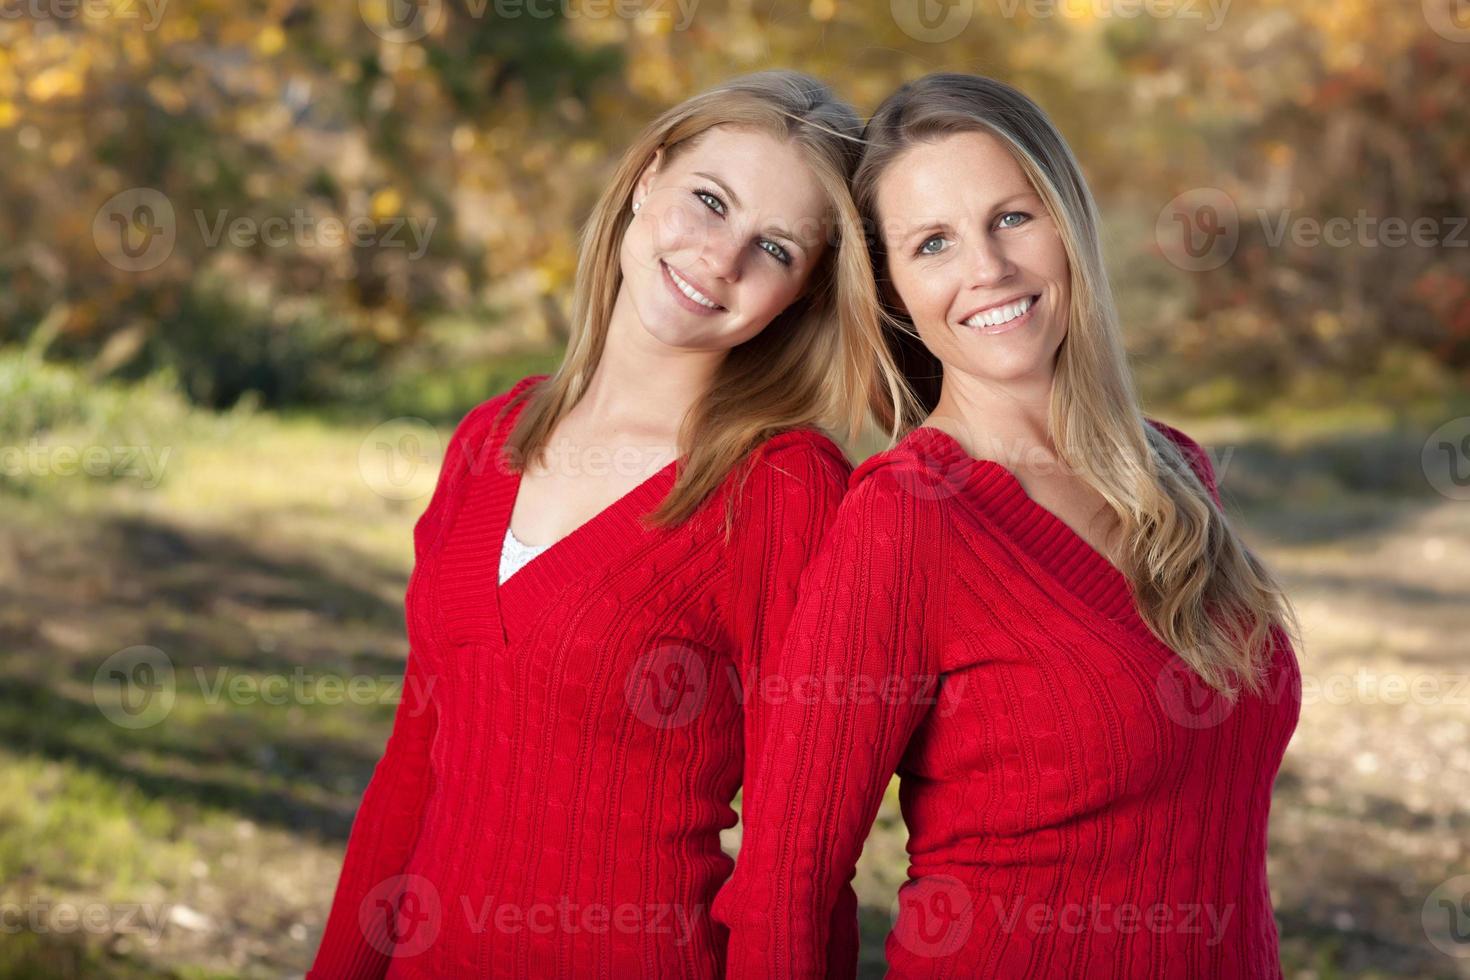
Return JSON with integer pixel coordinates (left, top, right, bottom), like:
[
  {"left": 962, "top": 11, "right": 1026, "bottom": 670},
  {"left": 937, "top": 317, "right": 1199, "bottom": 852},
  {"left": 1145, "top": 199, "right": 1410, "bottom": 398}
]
[{"left": 714, "top": 75, "right": 1299, "bottom": 980}]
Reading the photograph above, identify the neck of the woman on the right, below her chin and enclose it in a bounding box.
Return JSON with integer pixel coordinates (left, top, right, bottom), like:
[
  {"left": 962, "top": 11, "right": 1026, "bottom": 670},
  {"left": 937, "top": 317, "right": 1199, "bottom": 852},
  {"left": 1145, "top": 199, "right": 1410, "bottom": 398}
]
[{"left": 926, "top": 369, "right": 1054, "bottom": 470}]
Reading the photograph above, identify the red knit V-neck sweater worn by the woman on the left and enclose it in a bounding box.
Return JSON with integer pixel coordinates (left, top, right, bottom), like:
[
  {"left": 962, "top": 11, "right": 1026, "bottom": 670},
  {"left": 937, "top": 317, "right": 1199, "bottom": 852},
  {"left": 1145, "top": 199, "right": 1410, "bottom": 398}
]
[{"left": 309, "top": 376, "right": 856, "bottom": 980}]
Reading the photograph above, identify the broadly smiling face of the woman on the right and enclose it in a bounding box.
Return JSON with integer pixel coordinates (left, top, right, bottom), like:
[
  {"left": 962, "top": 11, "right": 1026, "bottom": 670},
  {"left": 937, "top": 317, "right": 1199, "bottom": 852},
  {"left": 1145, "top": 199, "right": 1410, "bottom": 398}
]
[{"left": 876, "top": 132, "right": 1072, "bottom": 383}]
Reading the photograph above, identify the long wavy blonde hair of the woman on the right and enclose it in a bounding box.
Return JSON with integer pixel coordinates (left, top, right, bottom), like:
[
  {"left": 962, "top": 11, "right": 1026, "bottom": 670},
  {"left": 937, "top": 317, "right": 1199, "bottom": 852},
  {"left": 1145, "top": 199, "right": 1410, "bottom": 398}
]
[{"left": 853, "top": 73, "right": 1295, "bottom": 696}]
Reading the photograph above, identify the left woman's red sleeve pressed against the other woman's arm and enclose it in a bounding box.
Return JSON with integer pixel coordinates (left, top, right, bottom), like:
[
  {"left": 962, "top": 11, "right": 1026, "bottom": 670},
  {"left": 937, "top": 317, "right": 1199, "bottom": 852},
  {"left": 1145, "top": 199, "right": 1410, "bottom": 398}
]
[{"left": 714, "top": 436, "right": 858, "bottom": 977}]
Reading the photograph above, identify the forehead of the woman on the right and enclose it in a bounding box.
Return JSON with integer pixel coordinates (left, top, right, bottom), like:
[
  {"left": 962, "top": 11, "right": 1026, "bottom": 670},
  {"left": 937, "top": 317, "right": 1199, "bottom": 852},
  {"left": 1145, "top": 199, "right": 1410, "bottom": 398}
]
[{"left": 878, "top": 132, "right": 1035, "bottom": 223}]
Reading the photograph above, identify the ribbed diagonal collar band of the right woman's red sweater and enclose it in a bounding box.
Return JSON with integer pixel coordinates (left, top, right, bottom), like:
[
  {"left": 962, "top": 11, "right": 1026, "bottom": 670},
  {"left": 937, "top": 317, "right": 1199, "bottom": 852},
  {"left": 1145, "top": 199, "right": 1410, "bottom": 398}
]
[{"left": 908, "top": 426, "right": 1147, "bottom": 629}]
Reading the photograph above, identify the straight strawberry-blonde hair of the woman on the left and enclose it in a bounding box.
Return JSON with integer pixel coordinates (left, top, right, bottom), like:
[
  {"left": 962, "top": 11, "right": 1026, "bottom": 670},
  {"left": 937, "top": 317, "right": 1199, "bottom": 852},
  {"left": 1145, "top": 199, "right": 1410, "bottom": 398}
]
[{"left": 506, "top": 71, "right": 904, "bottom": 525}]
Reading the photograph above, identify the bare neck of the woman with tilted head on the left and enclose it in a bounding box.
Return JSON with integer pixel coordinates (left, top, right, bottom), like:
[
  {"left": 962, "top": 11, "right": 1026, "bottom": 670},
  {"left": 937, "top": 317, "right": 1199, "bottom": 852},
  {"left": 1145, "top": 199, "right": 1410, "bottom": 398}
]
[{"left": 573, "top": 289, "right": 725, "bottom": 444}]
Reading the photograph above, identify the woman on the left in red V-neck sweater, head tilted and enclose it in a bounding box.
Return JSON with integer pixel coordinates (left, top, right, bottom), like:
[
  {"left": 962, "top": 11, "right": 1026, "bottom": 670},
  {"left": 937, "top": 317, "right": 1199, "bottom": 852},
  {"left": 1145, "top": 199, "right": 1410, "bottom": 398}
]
[{"left": 309, "top": 72, "right": 903, "bottom": 980}]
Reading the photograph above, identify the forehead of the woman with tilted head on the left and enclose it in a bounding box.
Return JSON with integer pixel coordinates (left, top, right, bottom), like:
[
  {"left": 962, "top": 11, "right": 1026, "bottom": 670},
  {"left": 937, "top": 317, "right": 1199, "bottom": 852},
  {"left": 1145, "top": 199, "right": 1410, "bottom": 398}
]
[{"left": 669, "top": 126, "right": 829, "bottom": 238}]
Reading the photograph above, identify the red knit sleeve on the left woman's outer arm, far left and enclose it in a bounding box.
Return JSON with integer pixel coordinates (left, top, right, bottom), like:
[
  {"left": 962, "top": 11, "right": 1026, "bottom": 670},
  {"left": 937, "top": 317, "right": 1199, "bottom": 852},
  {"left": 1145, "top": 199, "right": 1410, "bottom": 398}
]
[{"left": 306, "top": 382, "right": 525, "bottom": 980}]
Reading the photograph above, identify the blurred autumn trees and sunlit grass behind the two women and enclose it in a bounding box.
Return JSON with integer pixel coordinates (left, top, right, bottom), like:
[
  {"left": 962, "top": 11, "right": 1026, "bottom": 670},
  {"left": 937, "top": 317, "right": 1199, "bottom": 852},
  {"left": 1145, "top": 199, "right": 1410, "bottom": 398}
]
[{"left": 0, "top": 0, "right": 1470, "bottom": 979}]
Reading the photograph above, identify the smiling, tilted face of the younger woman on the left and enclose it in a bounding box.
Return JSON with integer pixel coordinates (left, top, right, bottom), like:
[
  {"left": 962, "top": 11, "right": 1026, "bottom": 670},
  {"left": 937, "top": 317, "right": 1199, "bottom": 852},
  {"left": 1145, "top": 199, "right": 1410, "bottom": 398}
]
[{"left": 622, "top": 126, "right": 829, "bottom": 350}]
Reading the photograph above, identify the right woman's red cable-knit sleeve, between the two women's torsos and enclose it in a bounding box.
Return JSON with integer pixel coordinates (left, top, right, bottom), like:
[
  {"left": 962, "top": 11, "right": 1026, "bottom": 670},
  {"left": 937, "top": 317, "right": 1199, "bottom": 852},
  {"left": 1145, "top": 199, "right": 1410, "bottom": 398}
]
[{"left": 713, "top": 472, "right": 945, "bottom": 979}]
